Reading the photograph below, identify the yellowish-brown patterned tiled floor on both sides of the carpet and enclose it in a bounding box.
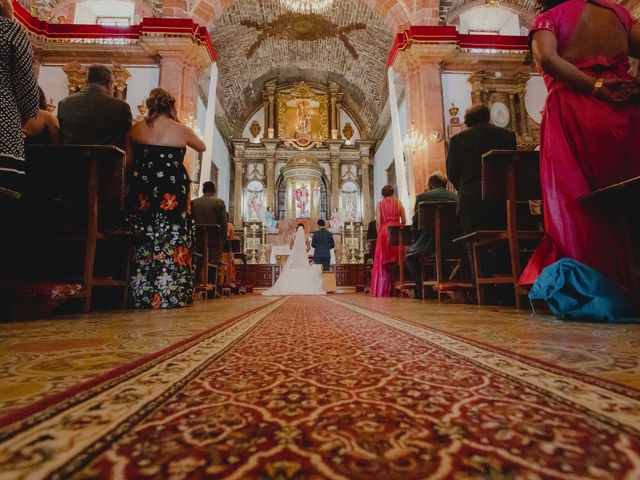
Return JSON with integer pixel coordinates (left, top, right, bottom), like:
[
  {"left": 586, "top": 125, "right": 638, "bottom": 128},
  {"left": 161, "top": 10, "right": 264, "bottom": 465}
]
[{"left": 0, "top": 294, "right": 640, "bottom": 415}]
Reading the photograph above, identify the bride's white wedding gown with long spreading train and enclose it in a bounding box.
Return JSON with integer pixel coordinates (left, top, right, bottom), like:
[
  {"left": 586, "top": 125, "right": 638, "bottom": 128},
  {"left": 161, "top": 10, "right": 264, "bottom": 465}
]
[{"left": 262, "top": 227, "right": 326, "bottom": 296}]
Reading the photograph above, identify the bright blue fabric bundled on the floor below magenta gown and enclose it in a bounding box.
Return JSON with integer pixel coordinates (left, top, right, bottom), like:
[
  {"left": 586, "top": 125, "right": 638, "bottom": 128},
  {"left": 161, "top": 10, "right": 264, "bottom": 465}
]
[{"left": 529, "top": 258, "right": 640, "bottom": 323}]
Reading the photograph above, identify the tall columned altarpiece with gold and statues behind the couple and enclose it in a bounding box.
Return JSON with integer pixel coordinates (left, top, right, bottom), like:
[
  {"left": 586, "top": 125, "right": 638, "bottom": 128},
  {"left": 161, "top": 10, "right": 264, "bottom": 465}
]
[{"left": 230, "top": 82, "right": 375, "bottom": 272}]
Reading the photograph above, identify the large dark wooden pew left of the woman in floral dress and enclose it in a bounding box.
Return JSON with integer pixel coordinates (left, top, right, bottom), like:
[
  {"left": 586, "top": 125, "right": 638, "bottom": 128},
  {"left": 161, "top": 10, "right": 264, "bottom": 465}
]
[{"left": 16, "top": 145, "right": 132, "bottom": 312}]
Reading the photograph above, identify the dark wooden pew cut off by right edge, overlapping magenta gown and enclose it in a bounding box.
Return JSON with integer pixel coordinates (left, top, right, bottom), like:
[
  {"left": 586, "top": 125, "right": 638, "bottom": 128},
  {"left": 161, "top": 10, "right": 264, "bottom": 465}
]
[{"left": 579, "top": 177, "right": 640, "bottom": 311}]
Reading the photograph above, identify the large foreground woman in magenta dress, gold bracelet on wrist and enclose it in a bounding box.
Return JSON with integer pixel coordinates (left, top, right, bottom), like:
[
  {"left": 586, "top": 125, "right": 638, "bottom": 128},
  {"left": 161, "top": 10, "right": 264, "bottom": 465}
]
[{"left": 520, "top": 0, "right": 640, "bottom": 290}]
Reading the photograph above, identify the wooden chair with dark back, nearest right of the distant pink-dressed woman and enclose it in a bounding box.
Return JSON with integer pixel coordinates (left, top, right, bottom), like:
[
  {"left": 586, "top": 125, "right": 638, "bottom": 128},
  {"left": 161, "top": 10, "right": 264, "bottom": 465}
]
[{"left": 418, "top": 202, "right": 473, "bottom": 301}]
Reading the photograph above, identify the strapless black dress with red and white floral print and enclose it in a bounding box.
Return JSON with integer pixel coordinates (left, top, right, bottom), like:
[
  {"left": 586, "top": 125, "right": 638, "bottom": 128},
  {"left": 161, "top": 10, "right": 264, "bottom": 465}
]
[{"left": 127, "top": 145, "right": 195, "bottom": 308}]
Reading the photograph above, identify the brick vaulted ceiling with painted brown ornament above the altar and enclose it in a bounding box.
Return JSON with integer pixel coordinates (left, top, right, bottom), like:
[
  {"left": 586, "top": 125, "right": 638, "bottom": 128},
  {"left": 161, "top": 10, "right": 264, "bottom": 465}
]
[{"left": 209, "top": 0, "right": 393, "bottom": 135}]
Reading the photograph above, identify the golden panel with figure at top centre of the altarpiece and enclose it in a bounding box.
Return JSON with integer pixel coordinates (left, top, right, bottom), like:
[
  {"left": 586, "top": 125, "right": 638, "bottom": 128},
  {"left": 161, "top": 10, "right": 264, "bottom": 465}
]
[{"left": 276, "top": 82, "right": 329, "bottom": 141}]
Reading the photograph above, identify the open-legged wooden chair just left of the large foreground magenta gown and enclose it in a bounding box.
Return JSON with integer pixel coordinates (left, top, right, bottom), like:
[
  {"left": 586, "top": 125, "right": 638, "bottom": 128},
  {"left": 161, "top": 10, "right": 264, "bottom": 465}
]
[{"left": 454, "top": 150, "right": 544, "bottom": 308}]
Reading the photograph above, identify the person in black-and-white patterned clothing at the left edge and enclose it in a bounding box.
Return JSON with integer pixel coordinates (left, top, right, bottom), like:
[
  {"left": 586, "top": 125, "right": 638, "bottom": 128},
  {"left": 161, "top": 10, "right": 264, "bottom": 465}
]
[{"left": 0, "top": 0, "right": 38, "bottom": 202}]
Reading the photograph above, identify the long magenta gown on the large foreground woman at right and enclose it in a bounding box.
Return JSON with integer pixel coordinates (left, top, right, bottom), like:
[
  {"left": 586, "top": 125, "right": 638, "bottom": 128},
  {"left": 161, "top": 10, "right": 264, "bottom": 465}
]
[{"left": 520, "top": 0, "right": 640, "bottom": 290}]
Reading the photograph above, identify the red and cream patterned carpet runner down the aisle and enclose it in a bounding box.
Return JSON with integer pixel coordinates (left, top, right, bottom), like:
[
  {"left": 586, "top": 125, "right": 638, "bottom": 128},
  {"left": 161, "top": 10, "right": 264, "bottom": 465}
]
[{"left": 0, "top": 297, "right": 640, "bottom": 480}]
